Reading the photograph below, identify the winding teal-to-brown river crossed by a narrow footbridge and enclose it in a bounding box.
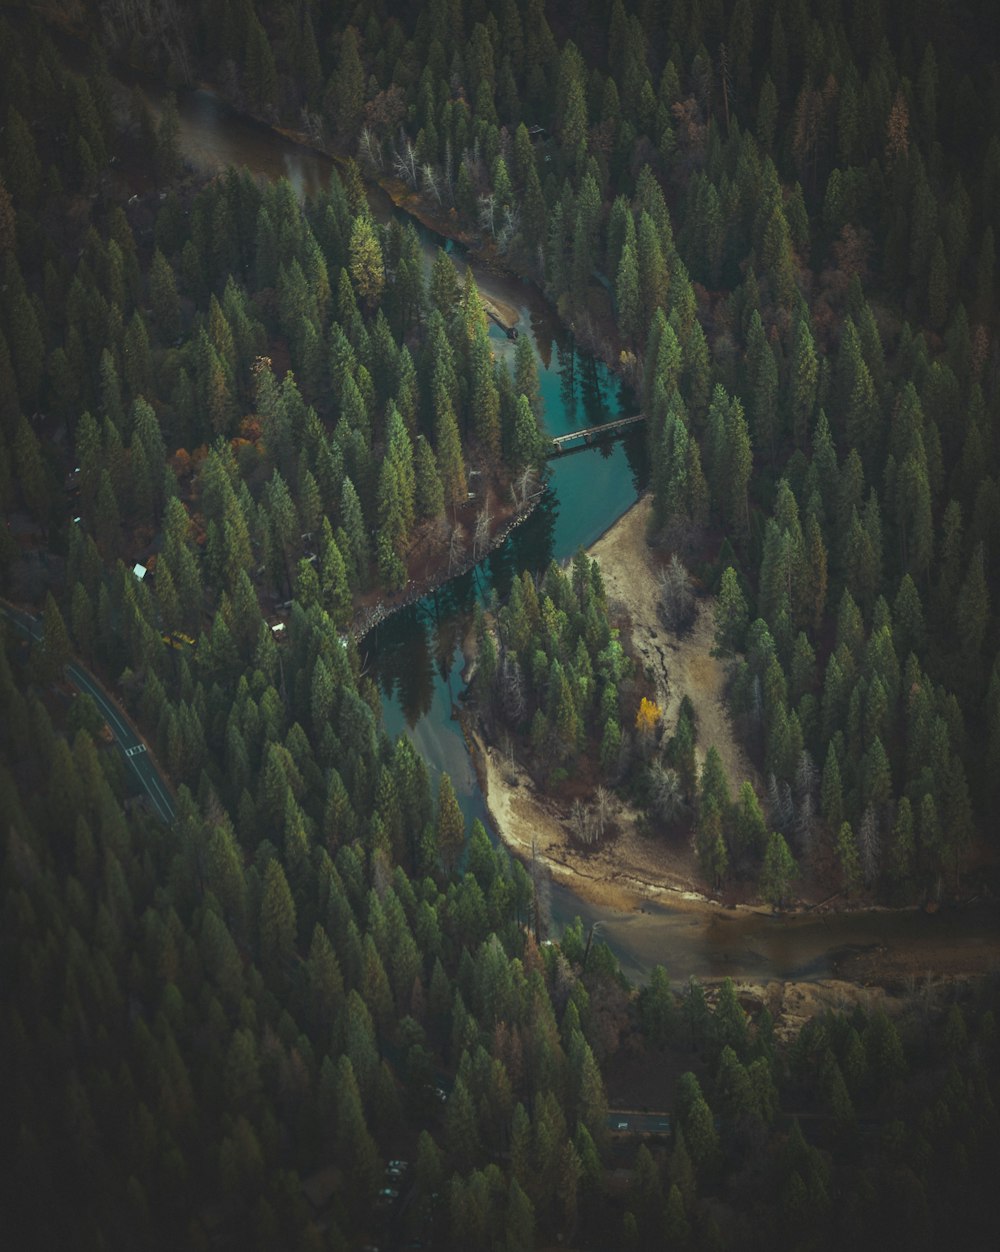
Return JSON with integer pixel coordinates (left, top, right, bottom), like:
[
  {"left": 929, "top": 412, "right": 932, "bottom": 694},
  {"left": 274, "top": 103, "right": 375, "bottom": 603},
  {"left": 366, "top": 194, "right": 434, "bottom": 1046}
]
[{"left": 158, "top": 86, "right": 1000, "bottom": 982}]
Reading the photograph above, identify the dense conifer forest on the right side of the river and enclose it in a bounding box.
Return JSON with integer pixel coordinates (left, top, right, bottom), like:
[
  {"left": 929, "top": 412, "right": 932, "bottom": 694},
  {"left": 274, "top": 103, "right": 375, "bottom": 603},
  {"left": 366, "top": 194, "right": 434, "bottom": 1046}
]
[{"left": 299, "top": 4, "right": 1000, "bottom": 900}]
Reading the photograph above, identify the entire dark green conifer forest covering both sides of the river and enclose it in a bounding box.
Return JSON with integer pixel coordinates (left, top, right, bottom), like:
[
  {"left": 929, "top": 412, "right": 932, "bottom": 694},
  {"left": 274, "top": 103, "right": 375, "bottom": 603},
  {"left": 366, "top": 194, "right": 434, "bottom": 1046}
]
[{"left": 0, "top": 0, "right": 1000, "bottom": 1252}]
